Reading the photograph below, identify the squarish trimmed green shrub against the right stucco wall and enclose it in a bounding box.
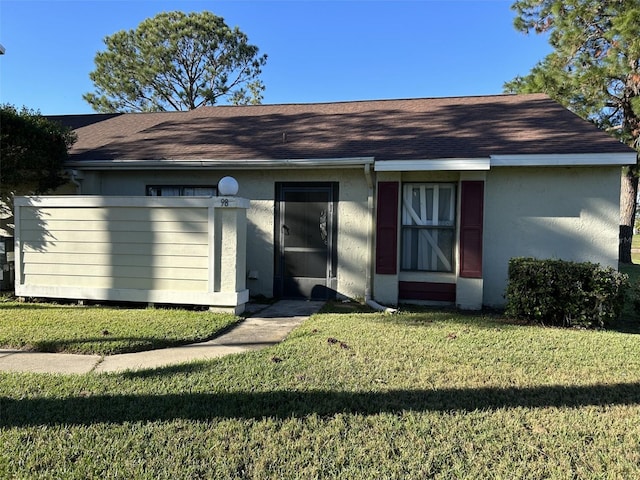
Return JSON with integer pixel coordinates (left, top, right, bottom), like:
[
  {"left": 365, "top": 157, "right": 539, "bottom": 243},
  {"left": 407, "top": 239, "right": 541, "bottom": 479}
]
[{"left": 505, "top": 258, "right": 628, "bottom": 328}]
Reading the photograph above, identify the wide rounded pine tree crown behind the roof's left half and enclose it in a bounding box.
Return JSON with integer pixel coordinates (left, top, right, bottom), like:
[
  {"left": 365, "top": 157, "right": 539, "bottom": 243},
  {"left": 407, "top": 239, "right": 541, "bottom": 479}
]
[{"left": 83, "top": 11, "right": 267, "bottom": 112}]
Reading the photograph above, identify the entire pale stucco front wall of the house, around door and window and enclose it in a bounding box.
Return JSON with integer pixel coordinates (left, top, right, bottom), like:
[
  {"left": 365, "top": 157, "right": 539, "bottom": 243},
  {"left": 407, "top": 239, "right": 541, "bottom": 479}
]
[{"left": 71, "top": 163, "right": 620, "bottom": 306}]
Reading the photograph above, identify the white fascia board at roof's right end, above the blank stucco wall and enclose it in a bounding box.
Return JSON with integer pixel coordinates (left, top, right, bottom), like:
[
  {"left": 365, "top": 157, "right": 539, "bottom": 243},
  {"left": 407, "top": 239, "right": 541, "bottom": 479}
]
[{"left": 491, "top": 152, "right": 637, "bottom": 167}]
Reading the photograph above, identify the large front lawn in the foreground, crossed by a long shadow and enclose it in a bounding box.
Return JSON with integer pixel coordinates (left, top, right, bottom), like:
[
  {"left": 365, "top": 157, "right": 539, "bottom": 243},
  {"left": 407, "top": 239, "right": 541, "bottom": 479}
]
[{"left": 0, "top": 312, "right": 640, "bottom": 479}]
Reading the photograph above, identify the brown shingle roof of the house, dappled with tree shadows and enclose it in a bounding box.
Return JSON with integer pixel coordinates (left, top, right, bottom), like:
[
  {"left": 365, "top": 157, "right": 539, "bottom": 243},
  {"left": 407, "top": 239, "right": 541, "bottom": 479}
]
[{"left": 62, "top": 94, "right": 631, "bottom": 165}]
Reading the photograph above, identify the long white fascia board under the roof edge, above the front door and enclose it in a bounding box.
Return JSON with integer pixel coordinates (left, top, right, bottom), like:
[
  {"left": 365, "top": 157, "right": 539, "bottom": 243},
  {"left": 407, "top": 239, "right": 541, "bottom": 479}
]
[{"left": 65, "top": 157, "right": 374, "bottom": 170}]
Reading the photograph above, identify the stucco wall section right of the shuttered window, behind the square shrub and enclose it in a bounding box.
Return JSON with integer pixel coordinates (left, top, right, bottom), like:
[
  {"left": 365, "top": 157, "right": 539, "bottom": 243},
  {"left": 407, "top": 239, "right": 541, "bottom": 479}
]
[{"left": 483, "top": 167, "right": 620, "bottom": 306}]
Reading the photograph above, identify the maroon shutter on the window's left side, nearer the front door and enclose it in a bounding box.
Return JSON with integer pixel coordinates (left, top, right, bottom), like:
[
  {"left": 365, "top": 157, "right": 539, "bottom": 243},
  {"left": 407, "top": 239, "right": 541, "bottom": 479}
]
[{"left": 376, "top": 182, "right": 399, "bottom": 274}]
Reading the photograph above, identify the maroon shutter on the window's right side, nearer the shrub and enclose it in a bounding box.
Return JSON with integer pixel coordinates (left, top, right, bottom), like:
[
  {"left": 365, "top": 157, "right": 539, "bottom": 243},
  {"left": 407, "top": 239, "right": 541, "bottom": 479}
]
[{"left": 460, "top": 181, "right": 484, "bottom": 278}]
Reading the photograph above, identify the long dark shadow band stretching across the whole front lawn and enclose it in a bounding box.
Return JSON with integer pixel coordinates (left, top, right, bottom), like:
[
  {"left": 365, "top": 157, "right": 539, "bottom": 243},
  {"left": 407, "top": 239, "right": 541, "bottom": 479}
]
[{"left": 0, "top": 383, "right": 640, "bottom": 427}]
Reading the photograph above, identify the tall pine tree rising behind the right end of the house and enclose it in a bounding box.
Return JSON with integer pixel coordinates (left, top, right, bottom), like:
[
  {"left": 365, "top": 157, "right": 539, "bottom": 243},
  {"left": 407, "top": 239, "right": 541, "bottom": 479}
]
[{"left": 505, "top": 0, "right": 640, "bottom": 263}]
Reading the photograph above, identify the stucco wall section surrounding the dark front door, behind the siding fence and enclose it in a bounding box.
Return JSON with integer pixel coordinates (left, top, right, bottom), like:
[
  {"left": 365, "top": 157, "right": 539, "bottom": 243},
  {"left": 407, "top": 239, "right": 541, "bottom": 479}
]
[{"left": 82, "top": 168, "right": 368, "bottom": 298}]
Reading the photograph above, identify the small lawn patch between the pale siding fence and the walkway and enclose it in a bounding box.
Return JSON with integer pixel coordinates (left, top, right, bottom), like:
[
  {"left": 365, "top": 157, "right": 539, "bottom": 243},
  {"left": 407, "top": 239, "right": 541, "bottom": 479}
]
[{"left": 0, "top": 298, "right": 237, "bottom": 355}]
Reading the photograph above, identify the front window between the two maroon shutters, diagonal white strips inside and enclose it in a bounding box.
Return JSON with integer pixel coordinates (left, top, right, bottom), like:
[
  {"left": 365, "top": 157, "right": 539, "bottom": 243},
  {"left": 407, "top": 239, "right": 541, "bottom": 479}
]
[{"left": 400, "top": 181, "right": 458, "bottom": 273}]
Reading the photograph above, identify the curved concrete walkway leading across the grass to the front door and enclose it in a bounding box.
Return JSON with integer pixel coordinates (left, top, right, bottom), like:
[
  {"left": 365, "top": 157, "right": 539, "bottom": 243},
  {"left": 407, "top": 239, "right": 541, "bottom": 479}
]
[{"left": 0, "top": 300, "right": 324, "bottom": 374}]
